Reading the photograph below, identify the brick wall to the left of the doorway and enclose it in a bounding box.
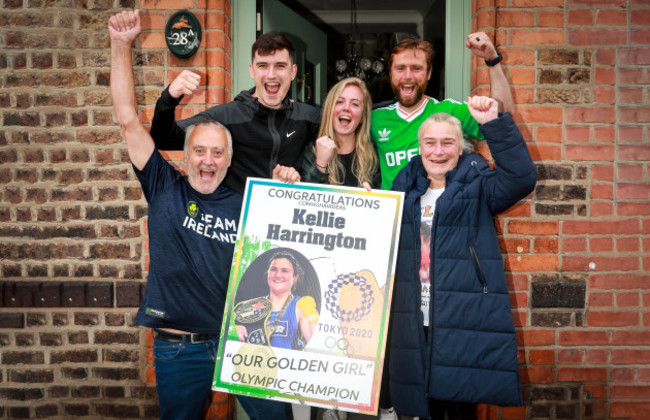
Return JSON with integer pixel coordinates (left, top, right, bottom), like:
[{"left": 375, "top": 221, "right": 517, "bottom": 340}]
[{"left": 0, "top": 0, "right": 233, "bottom": 419}]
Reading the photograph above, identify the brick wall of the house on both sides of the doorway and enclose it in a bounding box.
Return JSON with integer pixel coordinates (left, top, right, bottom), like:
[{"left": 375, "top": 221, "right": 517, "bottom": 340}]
[{"left": 0, "top": 0, "right": 650, "bottom": 420}]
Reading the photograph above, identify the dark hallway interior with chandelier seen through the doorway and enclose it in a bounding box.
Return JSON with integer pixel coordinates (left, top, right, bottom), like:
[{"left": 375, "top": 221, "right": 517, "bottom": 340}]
[{"left": 270, "top": 0, "right": 445, "bottom": 103}]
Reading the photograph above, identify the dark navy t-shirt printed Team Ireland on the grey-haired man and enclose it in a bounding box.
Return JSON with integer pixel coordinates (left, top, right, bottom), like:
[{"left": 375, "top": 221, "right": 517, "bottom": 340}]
[{"left": 134, "top": 149, "right": 242, "bottom": 334}]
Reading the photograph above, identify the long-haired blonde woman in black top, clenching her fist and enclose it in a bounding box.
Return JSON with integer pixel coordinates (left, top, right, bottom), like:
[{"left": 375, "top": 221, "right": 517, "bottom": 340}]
[{"left": 301, "top": 77, "right": 381, "bottom": 190}]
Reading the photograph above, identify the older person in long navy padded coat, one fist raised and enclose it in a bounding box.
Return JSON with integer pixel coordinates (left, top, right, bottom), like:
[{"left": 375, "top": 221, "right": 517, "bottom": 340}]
[{"left": 390, "top": 97, "right": 536, "bottom": 419}]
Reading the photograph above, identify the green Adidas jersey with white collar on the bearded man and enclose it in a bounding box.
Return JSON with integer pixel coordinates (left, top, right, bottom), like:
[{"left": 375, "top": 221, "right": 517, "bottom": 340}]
[{"left": 370, "top": 98, "right": 483, "bottom": 190}]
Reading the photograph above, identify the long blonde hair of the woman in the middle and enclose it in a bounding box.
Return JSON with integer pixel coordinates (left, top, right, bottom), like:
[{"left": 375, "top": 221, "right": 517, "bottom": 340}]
[{"left": 318, "top": 77, "right": 378, "bottom": 187}]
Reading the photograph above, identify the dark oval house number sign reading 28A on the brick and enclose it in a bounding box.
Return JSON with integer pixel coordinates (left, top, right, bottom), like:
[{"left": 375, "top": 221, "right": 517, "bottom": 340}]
[{"left": 165, "top": 10, "right": 201, "bottom": 58}]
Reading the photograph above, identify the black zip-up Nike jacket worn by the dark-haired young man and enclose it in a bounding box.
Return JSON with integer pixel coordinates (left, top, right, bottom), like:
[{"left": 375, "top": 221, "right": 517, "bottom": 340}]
[{"left": 151, "top": 87, "right": 320, "bottom": 193}]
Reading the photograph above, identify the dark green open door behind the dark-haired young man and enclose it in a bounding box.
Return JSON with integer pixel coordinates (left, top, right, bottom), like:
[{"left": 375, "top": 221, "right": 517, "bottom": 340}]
[{"left": 257, "top": 0, "right": 327, "bottom": 106}]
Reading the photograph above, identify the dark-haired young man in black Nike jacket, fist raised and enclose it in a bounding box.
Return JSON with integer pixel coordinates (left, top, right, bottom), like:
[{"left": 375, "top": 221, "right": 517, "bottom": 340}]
[{"left": 151, "top": 32, "right": 320, "bottom": 193}]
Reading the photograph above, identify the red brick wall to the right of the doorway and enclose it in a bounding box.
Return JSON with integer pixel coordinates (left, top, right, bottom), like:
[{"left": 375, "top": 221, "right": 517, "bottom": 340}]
[{"left": 473, "top": 0, "right": 650, "bottom": 420}]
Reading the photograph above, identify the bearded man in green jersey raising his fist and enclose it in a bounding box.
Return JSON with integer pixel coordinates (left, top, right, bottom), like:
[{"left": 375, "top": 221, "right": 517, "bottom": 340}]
[{"left": 370, "top": 32, "right": 514, "bottom": 190}]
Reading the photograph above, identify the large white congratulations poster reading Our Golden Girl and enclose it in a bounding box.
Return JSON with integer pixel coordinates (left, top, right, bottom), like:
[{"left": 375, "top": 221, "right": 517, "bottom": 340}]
[{"left": 213, "top": 178, "right": 403, "bottom": 414}]
